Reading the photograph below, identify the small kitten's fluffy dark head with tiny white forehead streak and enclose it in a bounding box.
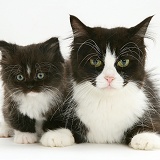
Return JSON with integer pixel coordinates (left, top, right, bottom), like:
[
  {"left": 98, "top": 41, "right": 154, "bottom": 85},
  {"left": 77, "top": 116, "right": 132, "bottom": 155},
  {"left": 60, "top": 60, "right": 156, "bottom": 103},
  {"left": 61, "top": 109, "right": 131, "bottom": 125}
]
[{"left": 0, "top": 38, "right": 64, "bottom": 94}]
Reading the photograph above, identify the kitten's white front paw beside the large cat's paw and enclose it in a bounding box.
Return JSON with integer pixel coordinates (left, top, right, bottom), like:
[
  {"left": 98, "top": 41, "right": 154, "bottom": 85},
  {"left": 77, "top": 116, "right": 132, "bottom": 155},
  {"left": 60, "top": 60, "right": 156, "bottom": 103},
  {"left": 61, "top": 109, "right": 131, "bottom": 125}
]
[{"left": 14, "top": 130, "right": 37, "bottom": 144}]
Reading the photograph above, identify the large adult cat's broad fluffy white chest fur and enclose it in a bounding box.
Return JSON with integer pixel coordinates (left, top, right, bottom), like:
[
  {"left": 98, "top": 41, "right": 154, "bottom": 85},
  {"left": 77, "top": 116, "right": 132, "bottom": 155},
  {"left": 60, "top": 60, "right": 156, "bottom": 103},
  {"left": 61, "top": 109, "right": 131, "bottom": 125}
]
[{"left": 74, "top": 82, "right": 147, "bottom": 143}]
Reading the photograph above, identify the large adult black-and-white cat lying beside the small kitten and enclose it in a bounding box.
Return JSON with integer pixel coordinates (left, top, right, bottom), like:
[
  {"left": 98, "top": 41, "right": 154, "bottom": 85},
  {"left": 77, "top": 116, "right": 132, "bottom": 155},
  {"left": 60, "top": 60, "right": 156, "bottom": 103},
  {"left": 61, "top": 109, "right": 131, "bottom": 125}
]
[{"left": 41, "top": 16, "right": 160, "bottom": 150}]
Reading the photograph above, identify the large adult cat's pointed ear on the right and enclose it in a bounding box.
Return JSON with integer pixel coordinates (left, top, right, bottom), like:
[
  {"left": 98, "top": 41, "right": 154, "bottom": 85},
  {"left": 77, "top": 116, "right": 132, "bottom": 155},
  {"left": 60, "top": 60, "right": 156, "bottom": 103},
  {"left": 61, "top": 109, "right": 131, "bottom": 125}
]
[{"left": 129, "top": 16, "right": 153, "bottom": 38}]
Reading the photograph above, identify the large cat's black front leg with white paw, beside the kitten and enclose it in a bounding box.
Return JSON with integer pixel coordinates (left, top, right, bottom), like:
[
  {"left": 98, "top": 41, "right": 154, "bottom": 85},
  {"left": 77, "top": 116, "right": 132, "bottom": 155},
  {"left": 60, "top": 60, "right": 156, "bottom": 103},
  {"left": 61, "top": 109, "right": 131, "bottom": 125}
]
[{"left": 40, "top": 114, "right": 75, "bottom": 147}]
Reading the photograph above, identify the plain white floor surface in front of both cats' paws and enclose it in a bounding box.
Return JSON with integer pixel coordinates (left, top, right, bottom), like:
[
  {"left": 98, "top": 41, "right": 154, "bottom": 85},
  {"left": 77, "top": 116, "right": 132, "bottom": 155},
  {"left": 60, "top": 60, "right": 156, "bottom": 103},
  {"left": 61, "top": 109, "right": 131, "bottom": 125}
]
[{"left": 0, "top": 138, "right": 160, "bottom": 160}]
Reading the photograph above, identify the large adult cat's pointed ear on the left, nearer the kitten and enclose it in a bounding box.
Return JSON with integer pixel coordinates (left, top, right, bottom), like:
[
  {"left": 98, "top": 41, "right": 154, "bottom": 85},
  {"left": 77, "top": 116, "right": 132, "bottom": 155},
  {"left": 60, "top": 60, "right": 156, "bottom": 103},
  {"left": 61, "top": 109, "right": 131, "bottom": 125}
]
[{"left": 70, "top": 15, "right": 89, "bottom": 36}]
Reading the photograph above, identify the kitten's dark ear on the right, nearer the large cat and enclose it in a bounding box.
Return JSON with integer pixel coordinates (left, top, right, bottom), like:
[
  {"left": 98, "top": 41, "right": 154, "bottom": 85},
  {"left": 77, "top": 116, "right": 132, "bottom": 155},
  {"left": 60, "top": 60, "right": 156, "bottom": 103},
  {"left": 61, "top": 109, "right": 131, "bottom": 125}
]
[{"left": 40, "top": 37, "right": 64, "bottom": 62}]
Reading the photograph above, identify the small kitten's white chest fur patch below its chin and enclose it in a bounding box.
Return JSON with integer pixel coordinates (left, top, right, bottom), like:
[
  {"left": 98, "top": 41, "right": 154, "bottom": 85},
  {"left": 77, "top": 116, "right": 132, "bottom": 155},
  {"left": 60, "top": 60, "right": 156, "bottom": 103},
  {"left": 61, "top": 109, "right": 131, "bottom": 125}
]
[{"left": 15, "top": 92, "right": 54, "bottom": 120}]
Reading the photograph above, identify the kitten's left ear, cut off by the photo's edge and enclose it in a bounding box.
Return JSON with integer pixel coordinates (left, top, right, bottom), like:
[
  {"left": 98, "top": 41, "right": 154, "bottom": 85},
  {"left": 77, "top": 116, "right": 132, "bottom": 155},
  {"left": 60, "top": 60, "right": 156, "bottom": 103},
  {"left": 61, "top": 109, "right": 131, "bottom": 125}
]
[{"left": 0, "top": 41, "right": 16, "bottom": 62}]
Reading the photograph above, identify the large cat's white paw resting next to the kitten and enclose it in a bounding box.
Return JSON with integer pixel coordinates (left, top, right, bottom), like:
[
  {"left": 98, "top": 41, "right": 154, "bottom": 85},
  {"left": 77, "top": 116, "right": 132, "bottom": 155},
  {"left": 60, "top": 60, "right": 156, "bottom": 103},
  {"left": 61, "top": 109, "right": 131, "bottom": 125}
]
[{"left": 40, "top": 129, "right": 74, "bottom": 147}]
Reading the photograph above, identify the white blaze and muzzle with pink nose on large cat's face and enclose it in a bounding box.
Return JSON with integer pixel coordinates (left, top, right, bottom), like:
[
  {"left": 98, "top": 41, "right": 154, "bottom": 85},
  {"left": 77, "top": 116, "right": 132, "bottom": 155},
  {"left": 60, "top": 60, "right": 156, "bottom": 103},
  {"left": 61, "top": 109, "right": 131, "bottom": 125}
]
[{"left": 96, "top": 47, "right": 124, "bottom": 89}]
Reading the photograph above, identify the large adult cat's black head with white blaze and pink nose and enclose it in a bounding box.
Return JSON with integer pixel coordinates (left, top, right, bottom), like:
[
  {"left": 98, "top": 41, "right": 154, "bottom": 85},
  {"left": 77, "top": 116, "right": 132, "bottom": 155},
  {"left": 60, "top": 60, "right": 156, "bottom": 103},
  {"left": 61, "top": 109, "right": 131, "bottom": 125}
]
[{"left": 70, "top": 16, "right": 152, "bottom": 89}]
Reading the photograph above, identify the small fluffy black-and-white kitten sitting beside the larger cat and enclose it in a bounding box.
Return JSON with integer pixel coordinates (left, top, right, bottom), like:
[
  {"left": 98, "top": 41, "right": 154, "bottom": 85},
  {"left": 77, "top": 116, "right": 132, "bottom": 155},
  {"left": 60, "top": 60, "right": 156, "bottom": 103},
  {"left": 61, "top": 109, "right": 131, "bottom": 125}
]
[{"left": 0, "top": 38, "right": 65, "bottom": 143}]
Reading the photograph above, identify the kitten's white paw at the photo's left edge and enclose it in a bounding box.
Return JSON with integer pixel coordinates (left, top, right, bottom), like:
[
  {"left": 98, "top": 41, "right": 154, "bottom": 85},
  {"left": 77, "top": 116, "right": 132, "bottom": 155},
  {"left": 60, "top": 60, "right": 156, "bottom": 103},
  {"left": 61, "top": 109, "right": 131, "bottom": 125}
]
[{"left": 0, "top": 124, "right": 13, "bottom": 138}]
